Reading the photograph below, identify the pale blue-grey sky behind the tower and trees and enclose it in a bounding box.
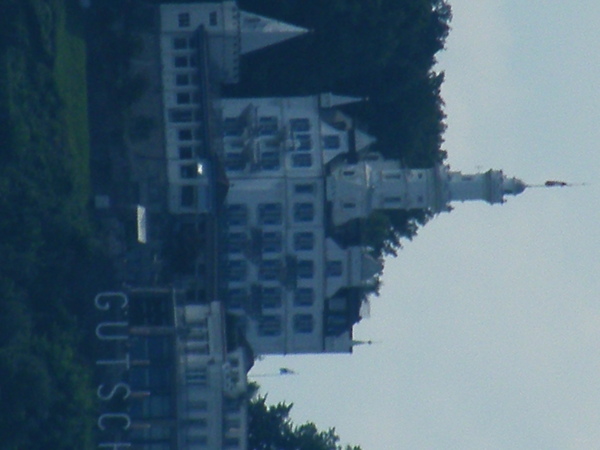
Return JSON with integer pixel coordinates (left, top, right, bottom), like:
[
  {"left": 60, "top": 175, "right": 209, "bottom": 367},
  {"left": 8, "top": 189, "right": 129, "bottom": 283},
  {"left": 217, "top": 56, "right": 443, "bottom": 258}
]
[{"left": 250, "top": 0, "right": 600, "bottom": 450}]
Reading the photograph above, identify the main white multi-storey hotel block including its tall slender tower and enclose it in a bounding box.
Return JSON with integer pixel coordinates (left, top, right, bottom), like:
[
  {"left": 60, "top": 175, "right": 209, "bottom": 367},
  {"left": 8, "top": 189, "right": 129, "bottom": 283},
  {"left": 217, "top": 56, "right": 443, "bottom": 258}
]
[{"left": 217, "top": 94, "right": 525, "bottom": 354}]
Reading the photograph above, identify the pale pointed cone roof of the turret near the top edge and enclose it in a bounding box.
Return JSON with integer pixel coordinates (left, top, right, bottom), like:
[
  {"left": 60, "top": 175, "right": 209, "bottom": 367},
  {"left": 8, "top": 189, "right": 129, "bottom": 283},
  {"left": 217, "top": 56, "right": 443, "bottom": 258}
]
[{"left": 240, "top": 11, "right": 308, "bottom": 54}]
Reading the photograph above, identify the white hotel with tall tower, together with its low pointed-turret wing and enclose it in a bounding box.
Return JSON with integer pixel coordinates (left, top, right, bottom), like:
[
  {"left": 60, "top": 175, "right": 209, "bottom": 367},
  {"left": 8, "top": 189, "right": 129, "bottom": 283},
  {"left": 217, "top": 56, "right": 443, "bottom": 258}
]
[{"left": 160, "top": 1, "right": 525, "bottom": 354}]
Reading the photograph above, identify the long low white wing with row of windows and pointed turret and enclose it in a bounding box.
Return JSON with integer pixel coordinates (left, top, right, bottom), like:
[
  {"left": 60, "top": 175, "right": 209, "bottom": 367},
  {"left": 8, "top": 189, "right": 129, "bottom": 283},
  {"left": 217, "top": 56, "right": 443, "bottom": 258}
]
[{"left": 160, "top": 1, "right": 307, "bottom": 214}]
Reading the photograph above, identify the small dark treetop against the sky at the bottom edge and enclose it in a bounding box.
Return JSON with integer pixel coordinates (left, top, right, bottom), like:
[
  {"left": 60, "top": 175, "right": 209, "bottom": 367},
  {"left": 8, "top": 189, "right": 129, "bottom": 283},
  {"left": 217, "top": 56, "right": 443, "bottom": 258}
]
[{"left": 248, "top": 396, "right": 360, "bottom": 450}]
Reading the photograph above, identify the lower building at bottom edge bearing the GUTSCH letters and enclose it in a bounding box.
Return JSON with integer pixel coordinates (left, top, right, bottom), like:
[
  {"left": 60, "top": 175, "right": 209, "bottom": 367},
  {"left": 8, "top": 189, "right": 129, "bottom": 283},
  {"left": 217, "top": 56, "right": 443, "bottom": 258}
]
[{"left": 95, "top": 288, "right": 252, "bottom": 450}]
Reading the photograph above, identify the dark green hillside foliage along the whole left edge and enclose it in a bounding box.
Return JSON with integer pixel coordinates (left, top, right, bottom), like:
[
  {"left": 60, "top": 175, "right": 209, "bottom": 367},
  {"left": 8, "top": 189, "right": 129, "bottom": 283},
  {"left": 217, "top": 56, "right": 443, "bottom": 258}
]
[{"left": 0, "top": 0, "right": 105, "bottom": 449}]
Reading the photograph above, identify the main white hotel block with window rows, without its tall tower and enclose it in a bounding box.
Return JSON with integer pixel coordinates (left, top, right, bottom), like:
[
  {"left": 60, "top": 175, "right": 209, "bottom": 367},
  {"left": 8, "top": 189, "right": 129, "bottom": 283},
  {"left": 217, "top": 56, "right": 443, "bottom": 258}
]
[{"left": 219, "top": 94, "right": 381, "bottom": 354}]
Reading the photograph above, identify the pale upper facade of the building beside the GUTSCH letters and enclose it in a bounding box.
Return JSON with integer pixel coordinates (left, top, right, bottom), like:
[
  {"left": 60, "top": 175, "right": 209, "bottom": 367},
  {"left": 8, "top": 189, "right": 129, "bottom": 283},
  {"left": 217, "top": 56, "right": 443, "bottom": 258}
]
[{"left": 177, "top": 302, "right": 248, "bottom": 450}]
